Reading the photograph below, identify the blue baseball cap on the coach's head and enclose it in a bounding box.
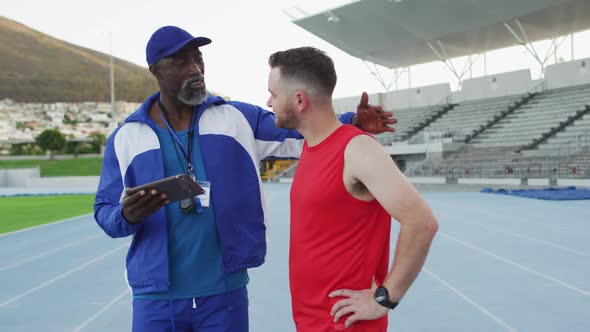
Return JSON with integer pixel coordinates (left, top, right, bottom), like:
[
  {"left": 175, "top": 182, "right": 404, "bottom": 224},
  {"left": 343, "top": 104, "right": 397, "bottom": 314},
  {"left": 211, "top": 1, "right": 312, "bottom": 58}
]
[{"left": 145, "top": 25, "right": 211, "bottom": 65}]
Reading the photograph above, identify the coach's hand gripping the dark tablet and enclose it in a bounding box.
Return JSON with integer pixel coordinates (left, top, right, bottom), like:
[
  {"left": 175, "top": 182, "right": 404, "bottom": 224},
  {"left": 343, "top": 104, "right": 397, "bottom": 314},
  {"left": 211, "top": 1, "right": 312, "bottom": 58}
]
[{"left": 123, "top": 189, "right": 169, "bottom": 224}]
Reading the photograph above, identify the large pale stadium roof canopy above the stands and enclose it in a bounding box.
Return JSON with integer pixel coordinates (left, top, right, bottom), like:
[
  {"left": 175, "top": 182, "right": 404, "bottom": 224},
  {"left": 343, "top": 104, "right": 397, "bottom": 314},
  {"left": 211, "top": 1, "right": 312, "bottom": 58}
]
[{"left": 294, "top": 0, "right": 590, "bottom": 68}]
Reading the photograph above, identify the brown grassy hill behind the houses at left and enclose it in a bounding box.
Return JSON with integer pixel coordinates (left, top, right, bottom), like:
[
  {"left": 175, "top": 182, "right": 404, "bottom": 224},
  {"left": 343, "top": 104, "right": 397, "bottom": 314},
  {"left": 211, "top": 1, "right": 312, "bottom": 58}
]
[{"left": 0, "top": 16, "right": 158, "bottom": 102}]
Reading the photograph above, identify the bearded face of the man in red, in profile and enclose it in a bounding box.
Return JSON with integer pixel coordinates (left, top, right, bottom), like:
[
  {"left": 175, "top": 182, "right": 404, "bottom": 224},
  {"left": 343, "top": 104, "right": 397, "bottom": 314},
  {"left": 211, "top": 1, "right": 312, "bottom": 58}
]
[{"left": 266, "top": 67, "right": 299, "bottom": 129}]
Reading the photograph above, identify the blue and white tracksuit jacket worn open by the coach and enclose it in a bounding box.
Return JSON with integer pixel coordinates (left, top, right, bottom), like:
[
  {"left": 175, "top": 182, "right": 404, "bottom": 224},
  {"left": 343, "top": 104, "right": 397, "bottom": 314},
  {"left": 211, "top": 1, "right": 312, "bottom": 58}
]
[{"left": 94, "top": 93, "right": 354, "bottom": 294}]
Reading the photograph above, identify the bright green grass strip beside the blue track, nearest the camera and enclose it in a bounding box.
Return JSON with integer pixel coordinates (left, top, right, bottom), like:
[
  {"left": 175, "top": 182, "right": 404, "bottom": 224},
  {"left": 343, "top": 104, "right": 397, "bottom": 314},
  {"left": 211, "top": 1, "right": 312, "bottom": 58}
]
[{"left": 0, "top": 195, "right": 94, "bottom": 234}]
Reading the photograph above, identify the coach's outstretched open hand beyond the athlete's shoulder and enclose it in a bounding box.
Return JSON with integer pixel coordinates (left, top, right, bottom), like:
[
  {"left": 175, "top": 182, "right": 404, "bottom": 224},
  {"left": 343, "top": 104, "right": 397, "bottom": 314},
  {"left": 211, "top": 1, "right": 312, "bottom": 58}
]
[{"left": 356, "top": 92, "right": 397, "bottom": 134}]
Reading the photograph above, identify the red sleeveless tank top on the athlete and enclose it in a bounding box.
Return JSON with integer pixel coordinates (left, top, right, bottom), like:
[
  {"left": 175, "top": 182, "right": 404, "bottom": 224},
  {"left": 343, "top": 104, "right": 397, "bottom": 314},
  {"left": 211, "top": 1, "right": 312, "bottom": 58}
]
[{"left": 289, "top": 125, "right": 391, "bottom": 332}]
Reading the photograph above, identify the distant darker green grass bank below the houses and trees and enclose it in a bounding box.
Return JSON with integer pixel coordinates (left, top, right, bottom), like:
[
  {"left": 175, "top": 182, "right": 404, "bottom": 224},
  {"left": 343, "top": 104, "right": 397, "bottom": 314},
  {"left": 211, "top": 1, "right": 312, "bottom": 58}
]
[{"left": 0, "top": 158, "right": 102, "bottom": 176}]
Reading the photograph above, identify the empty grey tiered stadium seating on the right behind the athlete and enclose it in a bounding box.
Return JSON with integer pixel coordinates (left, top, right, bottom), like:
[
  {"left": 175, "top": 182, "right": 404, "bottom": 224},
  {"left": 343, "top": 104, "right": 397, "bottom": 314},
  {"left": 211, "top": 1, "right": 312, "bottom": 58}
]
[{"left": 281, "top": 78, "right": 590, "bottom": 179}]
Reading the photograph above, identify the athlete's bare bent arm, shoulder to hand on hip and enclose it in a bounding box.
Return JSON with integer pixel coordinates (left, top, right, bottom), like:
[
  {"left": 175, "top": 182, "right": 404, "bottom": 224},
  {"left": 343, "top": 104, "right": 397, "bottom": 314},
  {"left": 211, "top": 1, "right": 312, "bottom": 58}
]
[{"left": 330, "top": 135, "right": 438, "bottom": 326}]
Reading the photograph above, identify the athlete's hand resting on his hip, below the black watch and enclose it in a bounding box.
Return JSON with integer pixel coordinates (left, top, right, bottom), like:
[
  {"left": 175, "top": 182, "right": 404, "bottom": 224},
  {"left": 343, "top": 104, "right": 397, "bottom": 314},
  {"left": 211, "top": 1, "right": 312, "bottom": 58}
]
[{"left": 328, "top": 280, "right": 389, "bottom": 328}]
